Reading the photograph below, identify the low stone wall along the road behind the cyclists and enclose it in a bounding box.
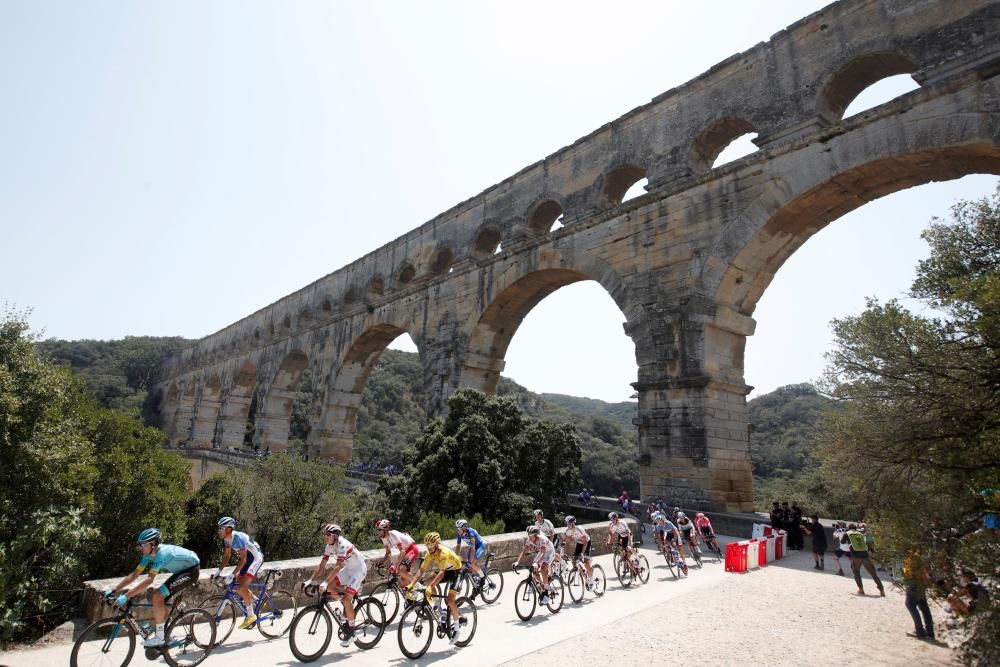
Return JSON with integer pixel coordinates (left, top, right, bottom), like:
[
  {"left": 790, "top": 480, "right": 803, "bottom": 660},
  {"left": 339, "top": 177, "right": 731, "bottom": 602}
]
[{"left": 82, "top": 519, "right": 637, "bottom": 622}]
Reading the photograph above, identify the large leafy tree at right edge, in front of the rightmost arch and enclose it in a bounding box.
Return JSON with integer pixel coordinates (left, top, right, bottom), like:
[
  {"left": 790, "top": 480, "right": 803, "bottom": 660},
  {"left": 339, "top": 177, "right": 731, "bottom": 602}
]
[{"left": 818, "top": 193, "right": 1000, "bottom": 663}]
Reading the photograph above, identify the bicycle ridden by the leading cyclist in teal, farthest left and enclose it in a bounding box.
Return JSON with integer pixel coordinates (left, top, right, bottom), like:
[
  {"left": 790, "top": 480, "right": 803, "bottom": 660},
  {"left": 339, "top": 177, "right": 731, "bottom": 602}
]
[{"left": 69, "top": 594, "right": 215, "bottom": 667}]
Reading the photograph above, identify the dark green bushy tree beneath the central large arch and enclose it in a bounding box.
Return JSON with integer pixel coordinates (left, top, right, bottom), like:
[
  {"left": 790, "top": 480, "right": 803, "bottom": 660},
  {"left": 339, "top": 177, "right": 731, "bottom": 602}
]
[{"left": 380, "top": 389, "right": 581, "bottom": 527}]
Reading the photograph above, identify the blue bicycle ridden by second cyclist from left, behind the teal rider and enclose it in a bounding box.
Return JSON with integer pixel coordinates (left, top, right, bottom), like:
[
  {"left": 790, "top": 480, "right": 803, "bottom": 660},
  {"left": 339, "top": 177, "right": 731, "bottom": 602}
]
[{"left": 198, "top": 570, "right": 298, "bottom": 646}]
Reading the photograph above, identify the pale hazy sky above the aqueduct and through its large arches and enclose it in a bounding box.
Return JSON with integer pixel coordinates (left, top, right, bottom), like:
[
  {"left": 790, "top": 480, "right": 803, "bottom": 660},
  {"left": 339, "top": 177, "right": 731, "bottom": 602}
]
[{"left": 0, "top": 0, "right": 996, "bottom": 400}]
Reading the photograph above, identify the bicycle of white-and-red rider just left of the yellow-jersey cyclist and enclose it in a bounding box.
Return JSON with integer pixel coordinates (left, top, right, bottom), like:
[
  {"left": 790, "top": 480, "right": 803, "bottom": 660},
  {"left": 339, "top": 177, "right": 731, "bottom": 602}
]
[{"left": 288, "top": 586, "right": 386, "bottom": 662}]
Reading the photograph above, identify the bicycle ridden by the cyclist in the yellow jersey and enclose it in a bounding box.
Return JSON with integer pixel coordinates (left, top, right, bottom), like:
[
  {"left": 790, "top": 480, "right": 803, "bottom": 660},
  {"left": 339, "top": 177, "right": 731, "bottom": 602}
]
[{"left": 396, "top": 587, "right": 479, "bottom": 660}]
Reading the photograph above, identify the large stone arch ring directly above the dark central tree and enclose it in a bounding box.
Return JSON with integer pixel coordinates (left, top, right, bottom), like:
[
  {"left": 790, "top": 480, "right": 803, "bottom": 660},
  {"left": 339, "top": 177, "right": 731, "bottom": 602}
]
[{"left": 459, "top": 257, "right": 642, "bottom": 393}]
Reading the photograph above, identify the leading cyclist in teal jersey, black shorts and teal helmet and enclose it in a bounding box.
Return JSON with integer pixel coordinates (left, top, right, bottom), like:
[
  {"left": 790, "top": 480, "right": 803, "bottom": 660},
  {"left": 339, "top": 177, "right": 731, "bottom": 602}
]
[{"left": 104, "top": 528, "right": 201, "bottom": 647}]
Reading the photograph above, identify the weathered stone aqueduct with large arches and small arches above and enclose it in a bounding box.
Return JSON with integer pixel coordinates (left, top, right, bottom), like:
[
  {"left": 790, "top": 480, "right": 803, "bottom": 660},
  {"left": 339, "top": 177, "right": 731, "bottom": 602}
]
[{"left": 156, "top": 0, "right": 1000, "bottom": 511}]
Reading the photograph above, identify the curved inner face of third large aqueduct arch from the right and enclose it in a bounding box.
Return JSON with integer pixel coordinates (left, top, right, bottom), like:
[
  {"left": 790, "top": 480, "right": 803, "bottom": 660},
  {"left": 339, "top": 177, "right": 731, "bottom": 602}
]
[{"left": 309, "top": 323, "right": 419, "bottom": 461}]
